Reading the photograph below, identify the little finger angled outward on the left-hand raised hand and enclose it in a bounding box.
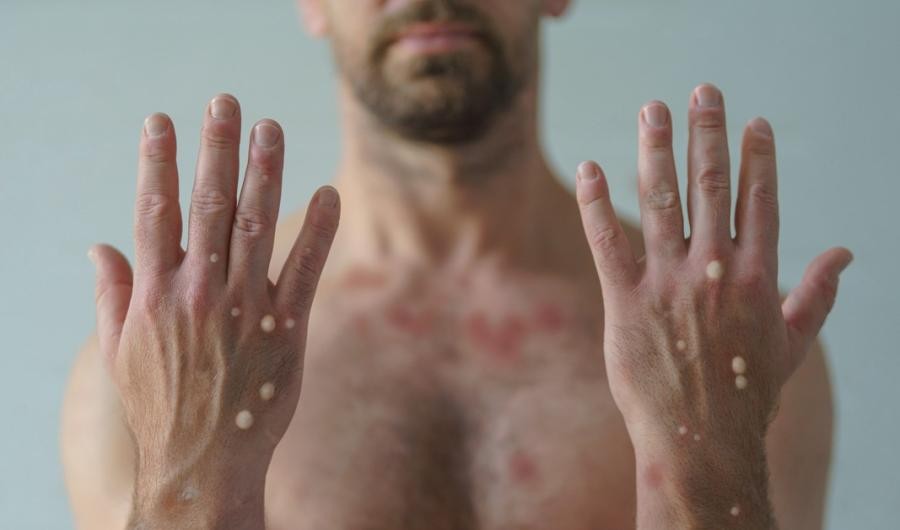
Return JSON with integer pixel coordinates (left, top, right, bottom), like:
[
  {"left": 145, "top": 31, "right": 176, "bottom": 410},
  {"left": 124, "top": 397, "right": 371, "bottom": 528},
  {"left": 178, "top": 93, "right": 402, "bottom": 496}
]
[{"left": 275, "top": 186, "right": 341, "bottom": 329}]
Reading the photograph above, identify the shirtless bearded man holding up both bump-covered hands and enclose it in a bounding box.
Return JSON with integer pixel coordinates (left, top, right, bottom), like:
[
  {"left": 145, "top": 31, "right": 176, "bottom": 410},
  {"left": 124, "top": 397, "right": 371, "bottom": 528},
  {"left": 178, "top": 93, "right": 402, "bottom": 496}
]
[{"left": 62, "top": 0, "right": 851, "bottom": 530}]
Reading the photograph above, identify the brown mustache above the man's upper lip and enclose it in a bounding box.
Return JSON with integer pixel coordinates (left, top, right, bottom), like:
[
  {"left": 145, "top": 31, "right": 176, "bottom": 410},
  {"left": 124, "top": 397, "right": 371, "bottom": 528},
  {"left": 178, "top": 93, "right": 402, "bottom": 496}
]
[{"left": 372, "top": 0, "right": 501, "bottom": 61}]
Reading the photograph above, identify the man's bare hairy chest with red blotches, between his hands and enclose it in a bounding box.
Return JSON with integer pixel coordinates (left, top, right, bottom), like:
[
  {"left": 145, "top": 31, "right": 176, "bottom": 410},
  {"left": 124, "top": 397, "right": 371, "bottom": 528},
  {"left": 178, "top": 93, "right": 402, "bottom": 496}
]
[{"left": 266, "top": 272, "right": 634, "bottom": 530}]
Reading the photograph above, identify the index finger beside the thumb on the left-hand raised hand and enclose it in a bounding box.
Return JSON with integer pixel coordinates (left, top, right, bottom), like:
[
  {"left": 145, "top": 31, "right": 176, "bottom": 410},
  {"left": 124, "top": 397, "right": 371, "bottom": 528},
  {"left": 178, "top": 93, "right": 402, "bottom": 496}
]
[{"left": 134, "top": 114, "right": 182, "bottom": 277}]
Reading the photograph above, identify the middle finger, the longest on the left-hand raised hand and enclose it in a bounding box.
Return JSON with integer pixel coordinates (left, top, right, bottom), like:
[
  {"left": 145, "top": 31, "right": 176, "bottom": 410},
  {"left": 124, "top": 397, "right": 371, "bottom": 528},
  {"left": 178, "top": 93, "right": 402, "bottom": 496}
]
[{"left": 187, "top": 94, "right": 241, "bottom": 282}]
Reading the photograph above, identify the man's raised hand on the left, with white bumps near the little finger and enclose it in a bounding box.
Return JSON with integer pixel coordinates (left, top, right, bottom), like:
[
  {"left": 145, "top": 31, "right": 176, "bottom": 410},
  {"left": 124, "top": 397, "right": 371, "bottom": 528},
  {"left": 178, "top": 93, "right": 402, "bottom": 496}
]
[{"left": 89, "top": 95, "right": 339, "bottom": 528}]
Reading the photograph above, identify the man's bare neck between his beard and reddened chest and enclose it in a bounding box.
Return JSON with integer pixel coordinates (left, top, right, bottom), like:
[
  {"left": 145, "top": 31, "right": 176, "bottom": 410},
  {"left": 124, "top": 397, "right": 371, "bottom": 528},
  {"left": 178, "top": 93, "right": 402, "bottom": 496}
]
[{"left": 335, "top": 81, "right": 565, "bottom": 267}]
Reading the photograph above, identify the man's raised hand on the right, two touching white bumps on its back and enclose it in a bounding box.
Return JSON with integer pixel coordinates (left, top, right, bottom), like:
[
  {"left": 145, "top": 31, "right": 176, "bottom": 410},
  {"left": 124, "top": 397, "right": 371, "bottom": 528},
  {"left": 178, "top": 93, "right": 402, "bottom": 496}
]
[{"left": 577, "top": 85, "right": 852, "bottom": 529}]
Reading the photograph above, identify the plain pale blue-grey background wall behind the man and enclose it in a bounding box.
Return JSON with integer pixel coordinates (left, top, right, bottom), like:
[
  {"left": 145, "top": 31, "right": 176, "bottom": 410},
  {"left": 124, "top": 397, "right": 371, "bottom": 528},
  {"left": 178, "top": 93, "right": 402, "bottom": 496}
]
[{"left": 0, "top": 0, "right": 900, "bottom": 530}]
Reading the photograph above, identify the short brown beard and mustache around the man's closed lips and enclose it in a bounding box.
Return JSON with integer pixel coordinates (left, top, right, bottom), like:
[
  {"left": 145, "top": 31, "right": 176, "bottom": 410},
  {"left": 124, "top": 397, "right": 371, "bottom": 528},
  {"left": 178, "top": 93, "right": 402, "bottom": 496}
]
[{"left": 335, "top": 0, "right": 535, "bottom": 144}]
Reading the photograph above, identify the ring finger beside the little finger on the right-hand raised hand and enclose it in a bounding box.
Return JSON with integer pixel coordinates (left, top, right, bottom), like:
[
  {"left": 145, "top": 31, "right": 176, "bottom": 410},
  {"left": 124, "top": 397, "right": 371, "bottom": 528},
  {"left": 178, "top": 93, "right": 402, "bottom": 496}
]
[{"left": 638, "top": 102, "right": 687, "bottom": 266}]
